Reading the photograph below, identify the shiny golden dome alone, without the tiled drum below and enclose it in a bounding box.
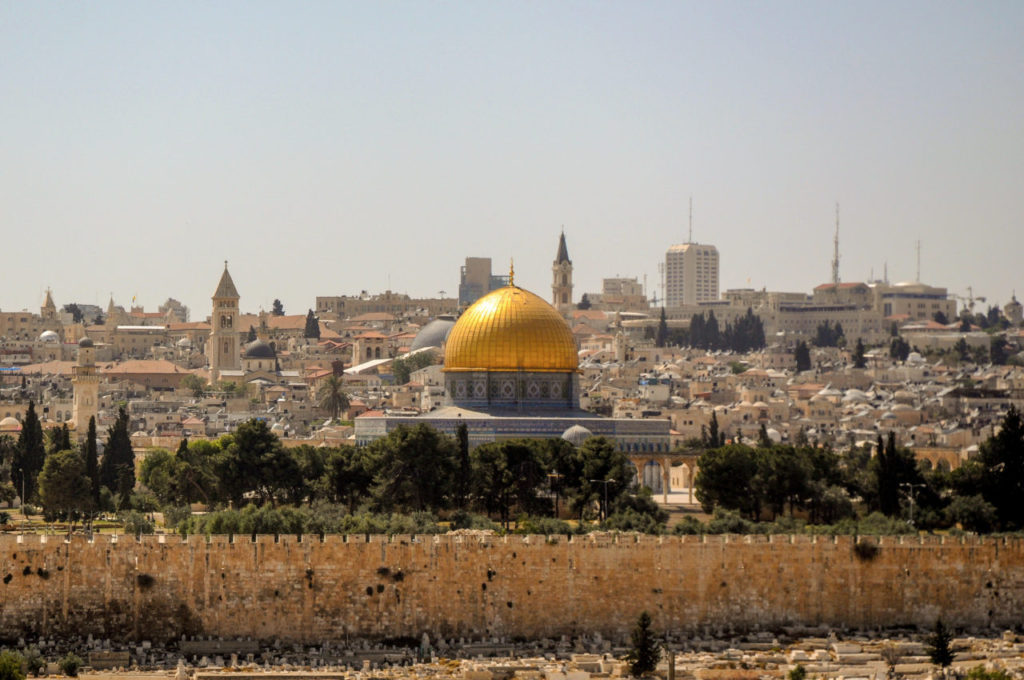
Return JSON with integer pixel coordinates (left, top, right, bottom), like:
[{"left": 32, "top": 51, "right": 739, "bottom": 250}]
[{"left": 444, "top": 286, "right": 580, "bottom": 373}]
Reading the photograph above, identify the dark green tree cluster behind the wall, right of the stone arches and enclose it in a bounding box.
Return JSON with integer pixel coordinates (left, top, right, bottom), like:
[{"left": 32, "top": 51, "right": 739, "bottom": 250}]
[{"left": 695, "top": 408, "right": 1024, "bottom": 533}]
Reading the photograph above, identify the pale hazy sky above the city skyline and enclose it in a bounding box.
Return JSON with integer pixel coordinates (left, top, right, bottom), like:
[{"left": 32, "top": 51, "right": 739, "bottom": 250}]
[{"left": 0, "top": 0, "right": 1024, "bottom": 320}]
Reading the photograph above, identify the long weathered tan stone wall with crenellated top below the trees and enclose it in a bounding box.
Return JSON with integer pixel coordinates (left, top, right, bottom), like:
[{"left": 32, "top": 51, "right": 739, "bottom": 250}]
[{"left": 0, "top": 536, "right": 1024, "bottom": 642}]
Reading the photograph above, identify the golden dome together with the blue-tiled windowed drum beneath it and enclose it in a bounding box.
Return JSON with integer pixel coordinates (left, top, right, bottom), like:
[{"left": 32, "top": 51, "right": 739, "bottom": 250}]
[{"left": 444, "top": 285, "right": 579, "bottom": 410}]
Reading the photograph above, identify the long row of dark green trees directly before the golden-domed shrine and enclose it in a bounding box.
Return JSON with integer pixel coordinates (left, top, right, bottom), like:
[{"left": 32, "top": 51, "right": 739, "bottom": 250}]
[{"left": 132, "top": 420, "right": 666, "bottom": 530}]
